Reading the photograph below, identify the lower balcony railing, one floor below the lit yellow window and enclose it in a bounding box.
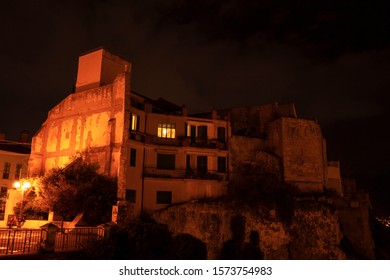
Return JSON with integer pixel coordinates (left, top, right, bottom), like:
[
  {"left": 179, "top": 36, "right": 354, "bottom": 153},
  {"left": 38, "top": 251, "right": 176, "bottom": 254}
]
[{"left": 144, "top": 168, "right": 227, "bottom": 181}]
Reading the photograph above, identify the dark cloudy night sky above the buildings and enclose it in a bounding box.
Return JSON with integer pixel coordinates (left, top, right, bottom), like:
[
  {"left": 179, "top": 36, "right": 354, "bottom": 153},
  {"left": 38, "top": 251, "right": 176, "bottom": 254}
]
[{"left": 0, "top": 0, "right": 390, "bottom": 212}]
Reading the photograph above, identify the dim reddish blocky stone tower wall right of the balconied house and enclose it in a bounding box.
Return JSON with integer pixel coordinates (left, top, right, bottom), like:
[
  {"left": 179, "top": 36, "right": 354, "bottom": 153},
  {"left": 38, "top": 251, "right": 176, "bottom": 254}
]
[{"left": 267, "top": 117, "right": 327, "bottom": 192}]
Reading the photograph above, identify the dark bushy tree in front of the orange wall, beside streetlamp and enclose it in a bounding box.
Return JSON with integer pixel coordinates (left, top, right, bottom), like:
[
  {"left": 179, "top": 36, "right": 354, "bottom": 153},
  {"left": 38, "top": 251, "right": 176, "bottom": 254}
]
[{"left": 25, "top": 157, "right": 117, "bottom": 225}]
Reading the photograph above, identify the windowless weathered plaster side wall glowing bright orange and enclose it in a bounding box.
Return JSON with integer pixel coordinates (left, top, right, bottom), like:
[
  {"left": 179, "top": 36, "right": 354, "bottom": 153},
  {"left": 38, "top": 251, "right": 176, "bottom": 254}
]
[{"left": 29, "top": 73, "right": 128, "bottom": 184}]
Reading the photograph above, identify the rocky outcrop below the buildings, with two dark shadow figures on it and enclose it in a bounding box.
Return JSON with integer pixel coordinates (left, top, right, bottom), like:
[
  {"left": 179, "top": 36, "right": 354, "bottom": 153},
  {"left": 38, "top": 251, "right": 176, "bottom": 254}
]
[{"left": 153, "top": 201, "right": 345, "bottom": 259}]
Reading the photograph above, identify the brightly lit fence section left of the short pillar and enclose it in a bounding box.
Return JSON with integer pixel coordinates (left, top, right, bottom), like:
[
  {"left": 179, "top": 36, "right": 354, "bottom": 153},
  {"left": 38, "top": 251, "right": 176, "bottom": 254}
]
[{"left": 0, "top": 229, "right": 46, "bottom": 255}]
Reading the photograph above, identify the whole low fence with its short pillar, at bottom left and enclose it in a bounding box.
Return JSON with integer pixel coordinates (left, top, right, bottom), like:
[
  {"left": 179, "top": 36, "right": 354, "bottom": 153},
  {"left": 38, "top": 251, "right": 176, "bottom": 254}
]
[{"left": 0, "top": 227, "right": 104, "bottom": 256}]
